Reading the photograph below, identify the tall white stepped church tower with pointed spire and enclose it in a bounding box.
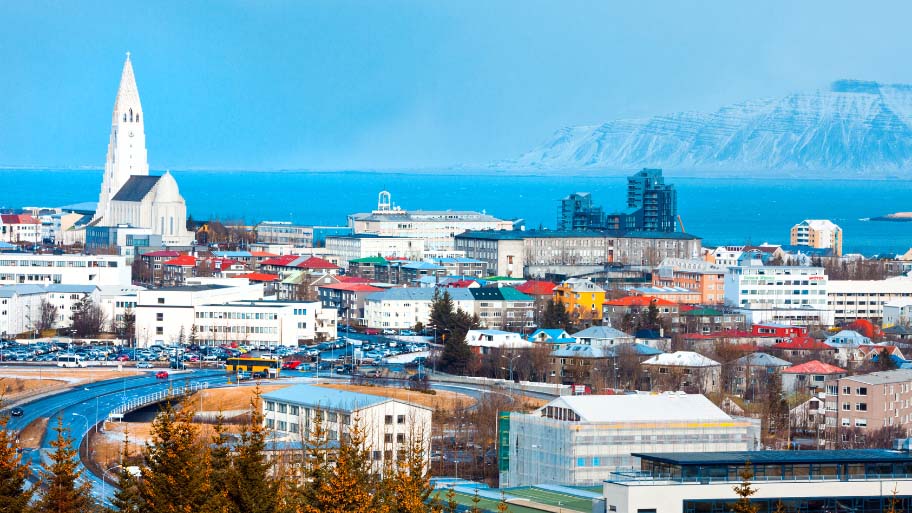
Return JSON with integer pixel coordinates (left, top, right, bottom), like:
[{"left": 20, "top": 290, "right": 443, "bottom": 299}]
[{"left": 94, "top": 52, "right": 149, "bottom": 225}]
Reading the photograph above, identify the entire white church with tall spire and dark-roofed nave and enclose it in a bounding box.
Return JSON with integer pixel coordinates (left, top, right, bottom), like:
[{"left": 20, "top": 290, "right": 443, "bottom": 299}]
[{"left": 91, "top": 53, "right": 194, "bottom": 246}]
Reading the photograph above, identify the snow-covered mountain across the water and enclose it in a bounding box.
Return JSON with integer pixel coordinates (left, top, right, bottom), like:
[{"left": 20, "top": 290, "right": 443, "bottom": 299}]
[{"left": 502, "top": 80, "right": 912, "bottom": 177}]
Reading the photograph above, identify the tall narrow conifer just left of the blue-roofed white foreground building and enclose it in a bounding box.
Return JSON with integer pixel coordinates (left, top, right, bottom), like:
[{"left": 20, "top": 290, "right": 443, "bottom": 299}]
[{"left": 230, "top": 385, "right": 277, "bottom": 513}]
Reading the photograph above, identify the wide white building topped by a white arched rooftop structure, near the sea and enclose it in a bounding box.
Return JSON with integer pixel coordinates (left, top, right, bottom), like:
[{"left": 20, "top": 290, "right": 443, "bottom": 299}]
[{"left": 348, "top": 191, "right": 513, "bottom": 250}]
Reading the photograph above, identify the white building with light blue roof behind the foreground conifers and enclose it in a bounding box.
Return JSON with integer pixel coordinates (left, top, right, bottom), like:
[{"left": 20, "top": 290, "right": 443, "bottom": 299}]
[{"left": 263, "top": 385, "right": 432, "bottom": 471}]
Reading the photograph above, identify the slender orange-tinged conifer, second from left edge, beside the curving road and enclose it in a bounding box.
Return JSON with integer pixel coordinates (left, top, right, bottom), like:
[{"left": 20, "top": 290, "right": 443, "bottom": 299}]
[{"left": 35, "top": 417, "right": 98, "bottom": 513}]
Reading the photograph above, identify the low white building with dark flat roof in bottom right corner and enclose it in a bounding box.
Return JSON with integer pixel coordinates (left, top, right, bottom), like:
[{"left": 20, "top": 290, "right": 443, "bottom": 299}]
[{"left": 602, "top": 449, "right": 912, "bottom": 513}]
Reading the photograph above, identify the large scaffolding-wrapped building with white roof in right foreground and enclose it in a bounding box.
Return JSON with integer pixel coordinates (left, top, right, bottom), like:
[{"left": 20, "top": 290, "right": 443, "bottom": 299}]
[{"left": 498, "top": 393, "right": 760, "bottom": 487}]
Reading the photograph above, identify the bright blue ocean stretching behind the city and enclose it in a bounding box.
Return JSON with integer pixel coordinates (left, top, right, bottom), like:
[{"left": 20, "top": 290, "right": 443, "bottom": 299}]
[{"left": 0, "top": 169, "right": 912, "bottom": 256}]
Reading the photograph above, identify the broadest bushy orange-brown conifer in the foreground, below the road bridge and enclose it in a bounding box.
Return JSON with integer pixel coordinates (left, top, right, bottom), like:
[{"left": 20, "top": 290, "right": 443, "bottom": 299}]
[{"left": 140, "top": 403, "right": 210, "bottom": 513}]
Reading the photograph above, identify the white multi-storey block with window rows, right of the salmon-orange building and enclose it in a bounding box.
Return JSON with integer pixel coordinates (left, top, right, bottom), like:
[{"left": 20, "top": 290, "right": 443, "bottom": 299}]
[{"left": 725, "top": 260, "right": 833, "bottom": 326}]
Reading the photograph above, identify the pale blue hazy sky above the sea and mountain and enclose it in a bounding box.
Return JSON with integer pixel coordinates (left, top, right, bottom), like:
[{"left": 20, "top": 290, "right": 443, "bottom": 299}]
[{"left": 0, "top": 0, "right": 912, "bottom": 170}]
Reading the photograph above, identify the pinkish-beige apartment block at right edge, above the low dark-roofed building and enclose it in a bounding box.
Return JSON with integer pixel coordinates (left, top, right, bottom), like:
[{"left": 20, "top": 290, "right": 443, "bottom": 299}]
[{"left": 825, "top": 369, "right": 912, "bottom": 436}]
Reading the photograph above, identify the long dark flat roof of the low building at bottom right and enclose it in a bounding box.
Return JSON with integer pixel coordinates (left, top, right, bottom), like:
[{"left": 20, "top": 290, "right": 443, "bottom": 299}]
[{"left": 631, "top": 449, "right": 912, "bottom": 465}]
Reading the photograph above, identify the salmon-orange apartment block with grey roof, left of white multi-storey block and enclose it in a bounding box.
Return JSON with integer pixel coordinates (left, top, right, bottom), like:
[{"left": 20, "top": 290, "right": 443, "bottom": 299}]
[{"left": 652, "top": 258, "right": 726, "bottom": 305}]
